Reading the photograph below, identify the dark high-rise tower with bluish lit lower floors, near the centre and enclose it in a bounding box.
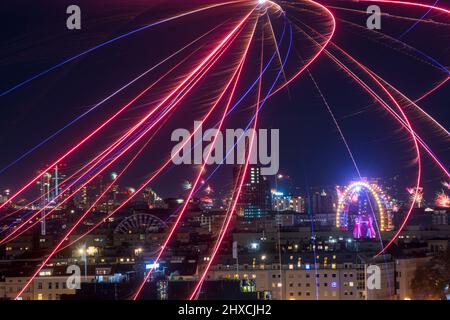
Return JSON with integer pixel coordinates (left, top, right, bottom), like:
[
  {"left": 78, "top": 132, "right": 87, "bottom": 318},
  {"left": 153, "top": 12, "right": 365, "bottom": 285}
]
[{"left": 233, "top": 165, "right": 272, "bottom": 220}]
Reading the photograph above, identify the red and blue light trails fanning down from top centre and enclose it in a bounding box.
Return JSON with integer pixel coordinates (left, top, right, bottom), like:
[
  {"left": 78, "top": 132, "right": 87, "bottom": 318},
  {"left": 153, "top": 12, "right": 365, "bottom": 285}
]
[{"left": 0, "top": 0, "right": 450, "bottom": 300}]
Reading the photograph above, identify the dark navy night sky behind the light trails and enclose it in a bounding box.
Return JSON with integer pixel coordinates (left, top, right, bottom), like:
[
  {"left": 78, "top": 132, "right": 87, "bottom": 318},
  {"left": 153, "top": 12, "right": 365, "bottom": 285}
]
[{"left": 0, "top": 0, "right": 450, "bottom": 202}]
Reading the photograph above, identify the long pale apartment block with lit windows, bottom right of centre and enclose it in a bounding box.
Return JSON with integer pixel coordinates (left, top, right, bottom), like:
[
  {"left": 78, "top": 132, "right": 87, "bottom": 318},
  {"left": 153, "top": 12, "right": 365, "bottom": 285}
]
[{"left": 208, "top": 254, "right": 395, "bottom": 300}]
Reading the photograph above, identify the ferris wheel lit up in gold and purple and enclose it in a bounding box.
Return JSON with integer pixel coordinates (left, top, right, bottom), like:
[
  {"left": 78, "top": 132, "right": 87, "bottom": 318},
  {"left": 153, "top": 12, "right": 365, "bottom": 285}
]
[{"left": 336, "top": 181, "right": 396, "bottom": 239}]
